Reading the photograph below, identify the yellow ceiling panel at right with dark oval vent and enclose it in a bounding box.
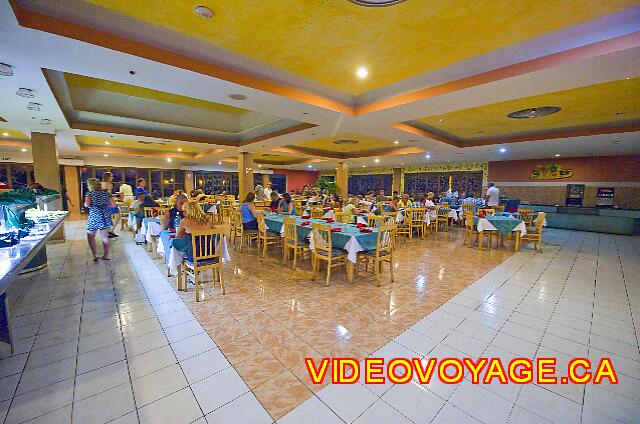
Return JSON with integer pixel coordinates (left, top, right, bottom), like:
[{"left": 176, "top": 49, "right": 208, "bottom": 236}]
[{"left": 419, "top": 78, "right": 640, "bottom": 139}]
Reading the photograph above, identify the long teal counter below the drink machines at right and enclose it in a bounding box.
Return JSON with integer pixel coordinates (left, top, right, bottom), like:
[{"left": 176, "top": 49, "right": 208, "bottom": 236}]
[{"left": 520, "top": 205, "right": 640, "bottom": 236}]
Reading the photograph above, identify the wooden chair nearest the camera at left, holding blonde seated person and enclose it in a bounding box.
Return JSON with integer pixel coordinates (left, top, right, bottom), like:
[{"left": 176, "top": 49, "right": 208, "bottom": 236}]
[{"left": 178, "top": 228, "right": 225, "bottom": 302}]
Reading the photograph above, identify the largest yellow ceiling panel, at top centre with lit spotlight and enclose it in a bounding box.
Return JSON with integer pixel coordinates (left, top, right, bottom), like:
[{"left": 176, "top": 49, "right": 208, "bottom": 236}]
[{"left": 88, "top": 0, "right": 637, "bottom": 94}]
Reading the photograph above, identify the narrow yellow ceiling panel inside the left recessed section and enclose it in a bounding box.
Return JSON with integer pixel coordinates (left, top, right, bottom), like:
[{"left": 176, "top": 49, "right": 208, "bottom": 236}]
[{"left": 64, "top": 73, "right": 249, "bottom": 115}]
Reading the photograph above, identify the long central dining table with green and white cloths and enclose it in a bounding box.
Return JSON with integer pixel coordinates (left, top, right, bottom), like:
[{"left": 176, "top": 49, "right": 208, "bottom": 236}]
[{"left": 264, "top": 214, "right": 378, "bottom": 281}]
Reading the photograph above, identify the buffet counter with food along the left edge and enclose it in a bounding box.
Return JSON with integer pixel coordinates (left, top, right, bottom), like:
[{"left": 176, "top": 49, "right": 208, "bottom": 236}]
[{"left": 0, "top": 211, "right": 69, "bottom": 352}]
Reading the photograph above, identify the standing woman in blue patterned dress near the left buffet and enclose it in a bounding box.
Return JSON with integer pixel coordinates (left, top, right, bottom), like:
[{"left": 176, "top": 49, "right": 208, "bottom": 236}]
[{"left": 84, "top": 178, "right": 115, "bottom": 261}]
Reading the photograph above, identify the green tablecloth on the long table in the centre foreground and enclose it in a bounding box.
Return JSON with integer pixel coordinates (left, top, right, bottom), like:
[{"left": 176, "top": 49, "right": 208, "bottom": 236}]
[{"left": 264, "top": 214, "right": 378, "bottom": 251}]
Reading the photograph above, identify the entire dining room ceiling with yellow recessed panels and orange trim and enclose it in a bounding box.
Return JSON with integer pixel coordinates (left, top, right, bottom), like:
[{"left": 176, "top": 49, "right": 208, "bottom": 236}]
[{"left": 0, "top": 0, "right": 640, "bottom": 170}]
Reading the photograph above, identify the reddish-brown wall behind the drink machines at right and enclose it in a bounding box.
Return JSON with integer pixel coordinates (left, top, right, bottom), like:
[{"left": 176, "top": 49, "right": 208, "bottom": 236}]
[{"left": 489, "top": 155, "right": 640, "bottom": 209}]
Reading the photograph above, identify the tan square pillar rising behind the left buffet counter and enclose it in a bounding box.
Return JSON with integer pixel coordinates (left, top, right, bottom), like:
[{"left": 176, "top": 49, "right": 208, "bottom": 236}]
[{"left": 31, "top": 132, "right": 64, "bottom": 241}]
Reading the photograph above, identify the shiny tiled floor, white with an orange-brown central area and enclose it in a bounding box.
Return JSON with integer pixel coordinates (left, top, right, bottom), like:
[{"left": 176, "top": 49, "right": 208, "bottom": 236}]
[{"left": 0, "top": 224, "right": 640, "bottom": 424}]
